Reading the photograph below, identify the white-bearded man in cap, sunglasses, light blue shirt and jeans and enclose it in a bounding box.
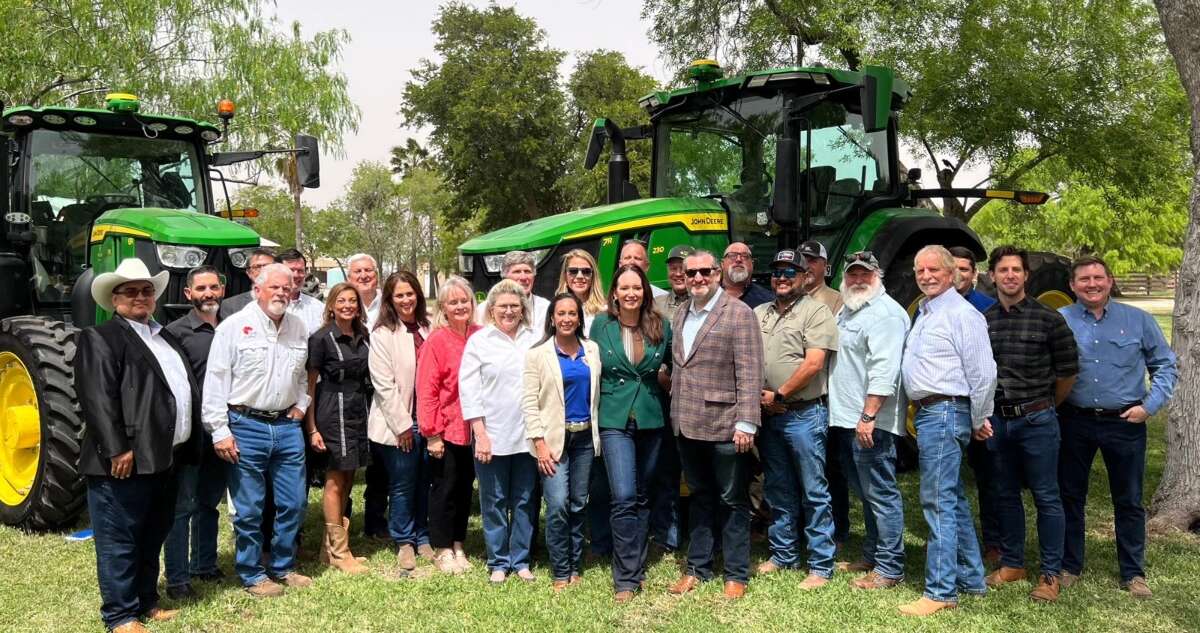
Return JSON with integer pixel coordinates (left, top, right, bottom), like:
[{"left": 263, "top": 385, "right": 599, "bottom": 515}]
[{"left": 829, "top": 251, "right": 908, "bottom": 589}]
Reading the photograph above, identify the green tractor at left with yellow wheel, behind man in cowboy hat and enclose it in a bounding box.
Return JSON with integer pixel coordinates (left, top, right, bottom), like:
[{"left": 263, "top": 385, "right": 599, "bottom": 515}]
[{"left": 0, "top": 94, "right": 319, "bottom": 530}]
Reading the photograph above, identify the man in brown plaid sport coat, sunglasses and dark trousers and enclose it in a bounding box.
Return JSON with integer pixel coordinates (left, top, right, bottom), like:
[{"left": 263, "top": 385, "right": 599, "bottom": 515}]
[{"left": 670, "top": 251, "right": 762, "bottom": 598}]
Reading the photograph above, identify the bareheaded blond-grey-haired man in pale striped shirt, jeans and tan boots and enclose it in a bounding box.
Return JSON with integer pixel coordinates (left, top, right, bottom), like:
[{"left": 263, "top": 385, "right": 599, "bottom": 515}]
[{"left": 900, "top": 246, "right": 996, "bottom": 616}]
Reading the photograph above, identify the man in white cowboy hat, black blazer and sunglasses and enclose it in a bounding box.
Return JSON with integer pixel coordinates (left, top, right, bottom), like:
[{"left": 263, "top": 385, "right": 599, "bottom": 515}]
[{"left": 74, "top": 259, "right": 200, "bottom": 633}]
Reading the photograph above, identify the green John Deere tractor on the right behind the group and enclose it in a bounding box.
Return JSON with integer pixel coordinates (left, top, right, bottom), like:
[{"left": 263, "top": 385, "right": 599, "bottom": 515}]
[{"left": 460, "top": 60, "right": 1073, "bottom": 309}]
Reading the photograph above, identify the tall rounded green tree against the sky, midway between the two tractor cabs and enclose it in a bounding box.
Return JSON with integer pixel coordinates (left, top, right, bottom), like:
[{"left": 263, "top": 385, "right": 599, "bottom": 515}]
[{"left": 400, "top": 2, "right": 570, "bottom": 229}]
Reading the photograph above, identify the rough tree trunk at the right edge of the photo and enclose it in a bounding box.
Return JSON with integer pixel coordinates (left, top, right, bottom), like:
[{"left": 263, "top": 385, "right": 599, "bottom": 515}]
[{"left": 1150, "top": 0, "right": 1200, "bottom": 530}]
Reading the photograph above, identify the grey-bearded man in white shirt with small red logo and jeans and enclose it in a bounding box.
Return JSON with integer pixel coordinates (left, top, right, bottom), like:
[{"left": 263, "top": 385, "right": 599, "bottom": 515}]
[{"left": 203, "top": 264, "right": 312, "bottom": 597}]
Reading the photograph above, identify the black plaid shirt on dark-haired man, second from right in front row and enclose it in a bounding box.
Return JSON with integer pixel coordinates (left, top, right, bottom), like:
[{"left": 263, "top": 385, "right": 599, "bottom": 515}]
[{"left": 983, "top": 296, "right": 1079, "bottom": 403}]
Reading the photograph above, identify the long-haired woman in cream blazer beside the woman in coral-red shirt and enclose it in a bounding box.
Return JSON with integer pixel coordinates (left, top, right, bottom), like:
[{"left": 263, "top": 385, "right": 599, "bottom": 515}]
[{"left": 367, "top": 271, "right": 433, "bottom": 572}]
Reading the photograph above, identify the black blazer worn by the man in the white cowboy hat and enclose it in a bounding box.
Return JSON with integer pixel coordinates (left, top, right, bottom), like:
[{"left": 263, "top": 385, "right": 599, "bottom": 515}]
[{"left": 74, "top": 315, "right": 202, "bottom": 476}]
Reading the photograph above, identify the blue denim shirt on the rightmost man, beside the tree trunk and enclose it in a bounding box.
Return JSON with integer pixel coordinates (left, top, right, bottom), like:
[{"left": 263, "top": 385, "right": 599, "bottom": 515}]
[{"left": 1058, "top": 301, "right": 1178, "bottom": 415}]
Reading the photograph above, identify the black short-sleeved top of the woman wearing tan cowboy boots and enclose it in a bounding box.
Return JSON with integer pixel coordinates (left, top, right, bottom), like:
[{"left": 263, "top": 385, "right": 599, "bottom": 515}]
[{"left": 308, "top": 324, "right": 373, "bottom": 424}]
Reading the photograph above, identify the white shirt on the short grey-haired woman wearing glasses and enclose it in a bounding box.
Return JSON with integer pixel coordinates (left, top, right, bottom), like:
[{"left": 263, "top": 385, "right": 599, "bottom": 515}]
[{"left": 458, "top": 325, "right": 541, "bottom": 456}]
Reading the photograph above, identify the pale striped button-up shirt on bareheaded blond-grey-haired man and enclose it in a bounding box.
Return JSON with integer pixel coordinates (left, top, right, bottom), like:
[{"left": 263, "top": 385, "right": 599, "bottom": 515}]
[{"left": 900, "top": 288, "right": 996, "bottom": 428}]
